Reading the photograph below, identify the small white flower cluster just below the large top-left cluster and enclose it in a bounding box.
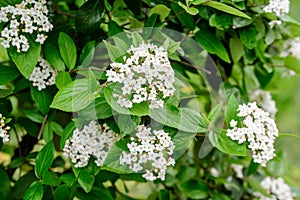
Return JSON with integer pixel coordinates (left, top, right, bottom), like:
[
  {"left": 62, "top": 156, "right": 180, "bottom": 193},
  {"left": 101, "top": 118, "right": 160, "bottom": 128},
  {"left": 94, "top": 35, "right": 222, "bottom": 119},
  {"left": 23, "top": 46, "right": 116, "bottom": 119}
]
[{"left": 29, "top": 58, "right": 57, "bottom": 90}]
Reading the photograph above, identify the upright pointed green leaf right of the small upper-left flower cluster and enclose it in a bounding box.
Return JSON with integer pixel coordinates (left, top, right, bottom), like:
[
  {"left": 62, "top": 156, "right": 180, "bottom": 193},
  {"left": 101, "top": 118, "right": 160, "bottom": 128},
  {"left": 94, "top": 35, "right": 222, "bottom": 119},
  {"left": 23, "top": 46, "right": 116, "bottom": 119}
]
[{"left": 58, "top": 32, "right": 77, "bottom": 70}]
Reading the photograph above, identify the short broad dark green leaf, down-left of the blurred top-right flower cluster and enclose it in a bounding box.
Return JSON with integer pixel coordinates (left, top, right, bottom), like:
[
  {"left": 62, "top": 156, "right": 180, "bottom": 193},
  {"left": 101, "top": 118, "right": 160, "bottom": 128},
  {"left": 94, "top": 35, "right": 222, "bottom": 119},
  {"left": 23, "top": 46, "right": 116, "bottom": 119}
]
[{"left": 239, "top": 25, "right": 257, "bottom": 49}]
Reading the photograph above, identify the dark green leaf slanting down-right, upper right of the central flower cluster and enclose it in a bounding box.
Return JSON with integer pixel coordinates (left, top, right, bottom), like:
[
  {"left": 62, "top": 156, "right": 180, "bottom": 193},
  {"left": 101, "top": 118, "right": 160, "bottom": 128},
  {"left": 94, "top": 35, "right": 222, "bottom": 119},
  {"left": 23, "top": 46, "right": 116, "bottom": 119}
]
[{"left": 195, "top": 29, "right": 230, "bottom": 63}]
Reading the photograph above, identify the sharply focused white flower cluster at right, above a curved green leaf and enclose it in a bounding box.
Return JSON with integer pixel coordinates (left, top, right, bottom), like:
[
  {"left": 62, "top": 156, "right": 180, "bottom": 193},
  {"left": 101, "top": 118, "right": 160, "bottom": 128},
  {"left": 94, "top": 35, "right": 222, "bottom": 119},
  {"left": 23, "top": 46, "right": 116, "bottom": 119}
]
[{"left": 226, "top": 102, "right": 278, "bottom": 167}]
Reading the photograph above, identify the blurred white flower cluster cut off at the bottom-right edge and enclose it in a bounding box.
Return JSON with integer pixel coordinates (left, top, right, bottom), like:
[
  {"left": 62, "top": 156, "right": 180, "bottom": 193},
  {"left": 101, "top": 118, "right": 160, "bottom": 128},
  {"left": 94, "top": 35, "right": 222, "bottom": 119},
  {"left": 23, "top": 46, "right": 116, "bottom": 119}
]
[{"left": 253, "top": 176, "right": 294, "bottom": 200}]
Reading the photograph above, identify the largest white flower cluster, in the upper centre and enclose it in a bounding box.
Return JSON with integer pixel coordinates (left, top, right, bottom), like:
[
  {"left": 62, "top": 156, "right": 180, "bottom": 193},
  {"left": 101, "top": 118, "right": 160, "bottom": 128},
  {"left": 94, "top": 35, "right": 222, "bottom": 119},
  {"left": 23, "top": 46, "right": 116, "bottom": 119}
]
[{"left": 106, "top": 43, "right": 175, "bottom": 108}]
